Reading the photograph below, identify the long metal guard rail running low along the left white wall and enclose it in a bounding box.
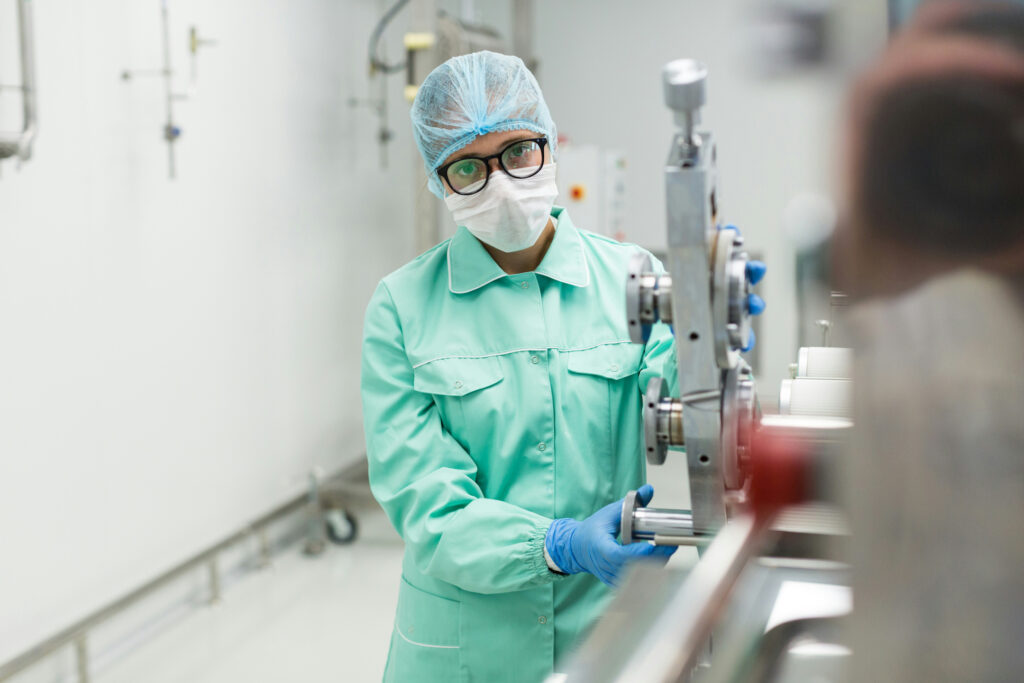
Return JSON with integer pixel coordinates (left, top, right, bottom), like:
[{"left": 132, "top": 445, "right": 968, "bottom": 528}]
[{"left": 0, "top": 492, "right": 308, "bottom": 681}]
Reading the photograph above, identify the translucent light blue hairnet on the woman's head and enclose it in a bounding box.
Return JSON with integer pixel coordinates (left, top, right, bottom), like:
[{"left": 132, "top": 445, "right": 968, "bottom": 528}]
[{"left": 410, "top": 50, "right": 557, "bottom": 197}]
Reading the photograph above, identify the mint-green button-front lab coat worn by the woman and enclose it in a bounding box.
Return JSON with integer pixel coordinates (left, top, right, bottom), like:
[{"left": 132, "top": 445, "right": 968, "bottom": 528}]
[{"left": 362, "top": 207, "right": 676, "bottom": 683}]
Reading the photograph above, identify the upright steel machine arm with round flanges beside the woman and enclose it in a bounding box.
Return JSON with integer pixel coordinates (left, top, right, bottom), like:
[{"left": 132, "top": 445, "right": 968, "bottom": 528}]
[{"left": 623, "top": 59, "right": 756, "bottom": 543}]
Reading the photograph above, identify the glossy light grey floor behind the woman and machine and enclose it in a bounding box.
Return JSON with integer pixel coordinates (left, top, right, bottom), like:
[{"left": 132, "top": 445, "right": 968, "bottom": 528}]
[{"left": 88, "top": 454, "right": 696, "bottom": 683}]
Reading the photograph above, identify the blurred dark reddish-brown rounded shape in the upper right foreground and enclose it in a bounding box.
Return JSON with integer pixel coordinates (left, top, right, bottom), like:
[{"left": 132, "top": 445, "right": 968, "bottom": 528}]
[{"left": 834, "top": 2, "right": 1024, "bottom": 300}]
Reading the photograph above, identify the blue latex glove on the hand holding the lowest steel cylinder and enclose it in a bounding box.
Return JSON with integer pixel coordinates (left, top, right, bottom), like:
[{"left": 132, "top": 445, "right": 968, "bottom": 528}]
[{"left": 544, "top": 483, "right": 676, "bottom": 586}]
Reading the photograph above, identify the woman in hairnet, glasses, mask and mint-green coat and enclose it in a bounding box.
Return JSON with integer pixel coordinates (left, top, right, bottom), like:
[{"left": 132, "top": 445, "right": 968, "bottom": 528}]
[{"left": 362, "top": 52, "right": 761, "bottom": 683}]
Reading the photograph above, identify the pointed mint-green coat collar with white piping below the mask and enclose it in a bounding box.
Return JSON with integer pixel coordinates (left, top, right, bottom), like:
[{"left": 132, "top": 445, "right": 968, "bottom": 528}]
[{"left": 447, "top": 206, "right": 590, "bottom": 294}]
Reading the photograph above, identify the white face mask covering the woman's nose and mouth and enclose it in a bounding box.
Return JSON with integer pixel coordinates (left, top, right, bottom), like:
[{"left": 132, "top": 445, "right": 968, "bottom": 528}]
[{"left": 444, "top": 164, "right": 558, "bottom": 252}]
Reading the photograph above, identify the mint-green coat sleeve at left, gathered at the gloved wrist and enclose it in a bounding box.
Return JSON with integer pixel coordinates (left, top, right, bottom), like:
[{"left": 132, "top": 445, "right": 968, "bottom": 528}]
[{"left": 361, "top": 283, "right": 558, "bottom": 593}]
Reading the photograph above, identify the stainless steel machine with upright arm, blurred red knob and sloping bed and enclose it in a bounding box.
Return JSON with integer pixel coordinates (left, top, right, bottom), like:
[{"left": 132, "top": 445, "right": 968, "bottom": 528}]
[{"left": 552, "top": 59, "right": 851, "bottom": 683}]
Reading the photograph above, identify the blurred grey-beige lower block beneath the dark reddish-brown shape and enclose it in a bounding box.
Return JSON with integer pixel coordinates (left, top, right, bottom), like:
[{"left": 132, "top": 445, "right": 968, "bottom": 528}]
[{"left": 846, "top": 270, "right": 1024, "bottom": 681}]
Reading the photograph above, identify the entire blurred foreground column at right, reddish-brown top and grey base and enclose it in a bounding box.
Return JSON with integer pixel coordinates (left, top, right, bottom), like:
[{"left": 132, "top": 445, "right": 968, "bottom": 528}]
[{"left": 836, "top": 2, "right": 1024, "bottom": 682}]
